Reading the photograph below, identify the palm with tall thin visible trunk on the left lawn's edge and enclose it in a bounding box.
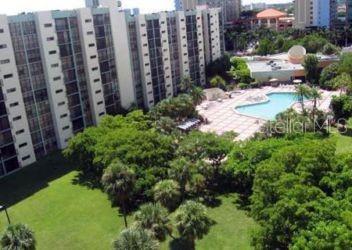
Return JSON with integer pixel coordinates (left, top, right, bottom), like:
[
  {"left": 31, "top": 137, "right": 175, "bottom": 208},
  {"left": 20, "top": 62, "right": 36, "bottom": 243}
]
[{"left": 101, "top": 161, "right": 135, "bottom": 228}]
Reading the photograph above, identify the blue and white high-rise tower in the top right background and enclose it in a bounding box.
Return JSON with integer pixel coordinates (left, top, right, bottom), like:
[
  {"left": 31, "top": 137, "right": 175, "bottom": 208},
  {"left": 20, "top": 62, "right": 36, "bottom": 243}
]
[{"left": 294, "top": 0, "right": 337, "bottom": 29}]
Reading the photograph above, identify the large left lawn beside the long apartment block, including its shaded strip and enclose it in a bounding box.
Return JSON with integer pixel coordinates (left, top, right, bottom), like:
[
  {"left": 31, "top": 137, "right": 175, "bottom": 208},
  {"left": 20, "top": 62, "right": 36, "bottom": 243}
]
[{"left": 0, "top": 152, "right": 123, "bottom": 249}]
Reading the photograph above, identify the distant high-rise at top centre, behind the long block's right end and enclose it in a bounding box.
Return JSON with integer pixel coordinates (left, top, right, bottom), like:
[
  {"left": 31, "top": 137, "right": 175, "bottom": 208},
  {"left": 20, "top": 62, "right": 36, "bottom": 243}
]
[{"left": 175, "top": 0, "right": 242, "bottom": 23}]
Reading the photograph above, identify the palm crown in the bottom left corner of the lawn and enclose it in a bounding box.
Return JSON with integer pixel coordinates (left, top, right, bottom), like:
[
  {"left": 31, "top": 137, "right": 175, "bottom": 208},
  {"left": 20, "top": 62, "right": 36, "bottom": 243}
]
[{"left": 0, "top": 224, "right": 36, "bottom": 250}]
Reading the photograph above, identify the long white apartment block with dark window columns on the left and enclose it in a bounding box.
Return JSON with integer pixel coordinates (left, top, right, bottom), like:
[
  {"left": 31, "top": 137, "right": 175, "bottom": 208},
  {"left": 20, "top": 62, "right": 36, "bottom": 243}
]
[{"left": 0, "top": 6, "right": 222, "bottom": 176}]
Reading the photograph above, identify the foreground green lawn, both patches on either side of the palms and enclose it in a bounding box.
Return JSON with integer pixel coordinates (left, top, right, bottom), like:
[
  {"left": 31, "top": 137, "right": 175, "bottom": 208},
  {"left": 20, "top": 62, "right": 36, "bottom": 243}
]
[{"left": 0, "top": 154, "right": 255, "bottom": 250}]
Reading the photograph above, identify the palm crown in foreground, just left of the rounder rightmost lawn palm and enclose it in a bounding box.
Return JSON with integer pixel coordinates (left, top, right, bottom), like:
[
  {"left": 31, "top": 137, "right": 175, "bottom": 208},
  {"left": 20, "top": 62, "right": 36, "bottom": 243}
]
[{"left": 134, "top": 203, "right": 171, "bottom": 241}]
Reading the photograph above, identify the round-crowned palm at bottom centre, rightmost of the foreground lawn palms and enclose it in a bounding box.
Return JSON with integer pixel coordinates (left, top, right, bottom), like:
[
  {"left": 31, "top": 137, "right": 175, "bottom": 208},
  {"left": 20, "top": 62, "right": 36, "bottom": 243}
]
[{"left": 175, "top": 201, "right": 212, "bottom": 249}]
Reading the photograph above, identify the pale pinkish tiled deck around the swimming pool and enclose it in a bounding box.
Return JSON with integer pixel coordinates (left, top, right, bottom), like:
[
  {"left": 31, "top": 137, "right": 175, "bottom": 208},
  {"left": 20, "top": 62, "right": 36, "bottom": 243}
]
[{"left": 197, "top": 85, "right": 339, "bottom": 140}]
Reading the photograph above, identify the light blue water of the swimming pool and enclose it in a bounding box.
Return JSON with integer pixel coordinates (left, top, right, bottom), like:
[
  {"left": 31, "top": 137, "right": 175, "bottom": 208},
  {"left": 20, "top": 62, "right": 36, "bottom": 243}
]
[{"left": 236, "top": 93, "right": 297, "bottom": 120}]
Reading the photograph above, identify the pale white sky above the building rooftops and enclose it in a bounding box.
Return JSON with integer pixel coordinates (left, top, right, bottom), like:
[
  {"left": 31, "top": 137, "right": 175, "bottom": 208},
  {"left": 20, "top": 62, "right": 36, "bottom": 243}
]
[{"left": 0, "top": 0, "right": 291, "bottom": 15}]
